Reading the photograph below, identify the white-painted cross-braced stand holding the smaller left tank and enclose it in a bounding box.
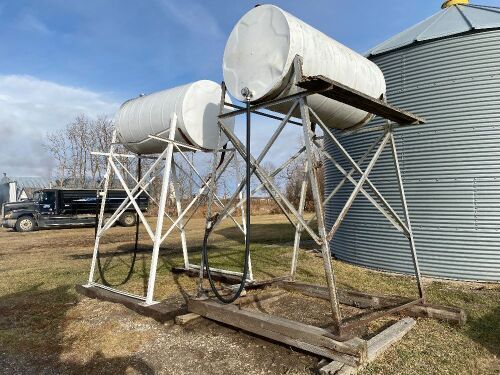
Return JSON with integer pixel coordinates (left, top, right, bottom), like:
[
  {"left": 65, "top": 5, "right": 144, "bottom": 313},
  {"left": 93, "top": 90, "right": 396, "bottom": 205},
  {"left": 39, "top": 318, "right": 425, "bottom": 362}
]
[{"left": 78, "top": 113, "right": 250, "bottom": 316}]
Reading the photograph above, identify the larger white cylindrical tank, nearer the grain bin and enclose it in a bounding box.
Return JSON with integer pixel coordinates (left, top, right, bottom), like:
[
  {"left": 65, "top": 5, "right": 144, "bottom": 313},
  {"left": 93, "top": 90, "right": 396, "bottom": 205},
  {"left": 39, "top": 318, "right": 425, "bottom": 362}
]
[{"left": 223, "top": 5, "right": 386, "bottom": 129}]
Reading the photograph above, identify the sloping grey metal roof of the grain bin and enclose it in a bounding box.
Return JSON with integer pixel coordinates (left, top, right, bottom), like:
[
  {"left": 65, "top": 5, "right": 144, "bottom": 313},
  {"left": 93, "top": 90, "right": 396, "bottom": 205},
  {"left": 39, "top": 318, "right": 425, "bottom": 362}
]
[{"left": 366, "top": 4, "right": 500, "bottom": 56}]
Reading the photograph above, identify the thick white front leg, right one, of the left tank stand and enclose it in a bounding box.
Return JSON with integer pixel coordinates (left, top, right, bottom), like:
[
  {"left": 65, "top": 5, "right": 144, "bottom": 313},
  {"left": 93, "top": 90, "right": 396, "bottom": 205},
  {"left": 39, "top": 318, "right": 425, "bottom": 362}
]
[{"left": 146, "top": 113, "right": 177, "bottom": 305}]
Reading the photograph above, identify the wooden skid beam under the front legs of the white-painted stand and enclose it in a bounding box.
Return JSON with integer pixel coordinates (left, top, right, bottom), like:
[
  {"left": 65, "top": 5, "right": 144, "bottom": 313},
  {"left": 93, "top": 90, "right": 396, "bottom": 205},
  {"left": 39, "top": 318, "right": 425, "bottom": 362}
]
[{"left": 75, "top": 285, "right": 187, "bottom": 323}]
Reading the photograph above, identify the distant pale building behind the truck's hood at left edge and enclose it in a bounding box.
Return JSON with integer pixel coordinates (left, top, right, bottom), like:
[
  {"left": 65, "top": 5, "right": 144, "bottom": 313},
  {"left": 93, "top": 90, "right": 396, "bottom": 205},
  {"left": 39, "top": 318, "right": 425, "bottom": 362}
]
[{"left": 0, "top": 173, "right": 51, "bottom": 205}]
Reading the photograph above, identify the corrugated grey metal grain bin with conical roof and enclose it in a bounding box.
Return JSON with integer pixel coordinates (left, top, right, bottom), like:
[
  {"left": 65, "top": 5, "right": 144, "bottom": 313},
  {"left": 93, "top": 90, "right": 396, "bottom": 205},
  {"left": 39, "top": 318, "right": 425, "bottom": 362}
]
[{"left": 326, "top": 1, "right": 500, "bottom": 281}]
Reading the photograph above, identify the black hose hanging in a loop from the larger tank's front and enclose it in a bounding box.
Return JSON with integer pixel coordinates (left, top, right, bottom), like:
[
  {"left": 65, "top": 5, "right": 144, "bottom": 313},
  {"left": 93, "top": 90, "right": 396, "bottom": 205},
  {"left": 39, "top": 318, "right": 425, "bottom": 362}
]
[{"left": 202, "top": 101, "right": 251, "bottom": 304}]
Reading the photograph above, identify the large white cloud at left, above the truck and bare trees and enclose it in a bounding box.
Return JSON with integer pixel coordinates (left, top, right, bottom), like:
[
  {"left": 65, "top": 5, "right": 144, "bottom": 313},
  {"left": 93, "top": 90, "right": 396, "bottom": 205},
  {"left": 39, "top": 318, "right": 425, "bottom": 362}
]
[{"left": 0, "top": 75, "right": 119, "bottom": 176}]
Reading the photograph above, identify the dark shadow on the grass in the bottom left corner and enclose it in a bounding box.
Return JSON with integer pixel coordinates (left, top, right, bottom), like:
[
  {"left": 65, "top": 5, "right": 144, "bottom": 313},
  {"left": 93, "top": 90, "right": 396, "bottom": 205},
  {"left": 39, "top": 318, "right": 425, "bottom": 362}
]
[{"left": 0, "top": 284, "right": 154, "bottom": 374}]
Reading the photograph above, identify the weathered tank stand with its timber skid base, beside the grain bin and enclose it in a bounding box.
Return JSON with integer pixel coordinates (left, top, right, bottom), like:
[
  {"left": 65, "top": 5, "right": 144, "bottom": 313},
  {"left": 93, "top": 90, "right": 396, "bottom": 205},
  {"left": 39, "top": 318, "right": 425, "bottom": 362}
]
[{"left": 188, "top": 56, "right": 465, "bottom": 368}]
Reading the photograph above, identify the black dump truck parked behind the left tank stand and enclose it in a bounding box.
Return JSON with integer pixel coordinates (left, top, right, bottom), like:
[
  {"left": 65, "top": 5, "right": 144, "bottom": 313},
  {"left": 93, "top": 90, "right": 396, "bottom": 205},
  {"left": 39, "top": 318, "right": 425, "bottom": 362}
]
[{"left": 2, "top": 188, "right": 149, "bottom": 232}]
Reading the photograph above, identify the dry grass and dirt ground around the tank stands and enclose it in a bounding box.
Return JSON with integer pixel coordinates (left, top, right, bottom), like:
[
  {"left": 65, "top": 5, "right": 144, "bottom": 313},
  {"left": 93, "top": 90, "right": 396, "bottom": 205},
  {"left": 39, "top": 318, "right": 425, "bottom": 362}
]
[{"left": 0, "top": 215, "right": 500, "bottom": 375}]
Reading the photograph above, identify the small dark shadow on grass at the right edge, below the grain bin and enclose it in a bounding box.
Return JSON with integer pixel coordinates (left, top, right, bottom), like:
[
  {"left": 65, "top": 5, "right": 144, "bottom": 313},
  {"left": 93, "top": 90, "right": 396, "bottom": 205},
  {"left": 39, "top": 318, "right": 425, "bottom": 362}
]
[{"left": 467, "top": 301, "right": 500, "bottom": 357}]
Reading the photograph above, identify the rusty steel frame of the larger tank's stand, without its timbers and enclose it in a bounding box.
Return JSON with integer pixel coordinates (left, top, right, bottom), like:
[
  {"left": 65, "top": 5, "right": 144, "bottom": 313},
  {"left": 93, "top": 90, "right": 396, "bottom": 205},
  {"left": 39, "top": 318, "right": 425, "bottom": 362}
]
[{"left": 193, "top": 56, "right": 425, "bottom": 339}]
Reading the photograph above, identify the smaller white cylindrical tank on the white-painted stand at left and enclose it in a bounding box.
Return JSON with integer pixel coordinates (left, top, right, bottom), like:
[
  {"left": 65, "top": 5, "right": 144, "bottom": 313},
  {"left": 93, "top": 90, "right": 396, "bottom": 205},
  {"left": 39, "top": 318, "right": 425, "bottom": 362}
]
[{"left": 115, "top": 80, "right": 234, "bottom": 154}]
